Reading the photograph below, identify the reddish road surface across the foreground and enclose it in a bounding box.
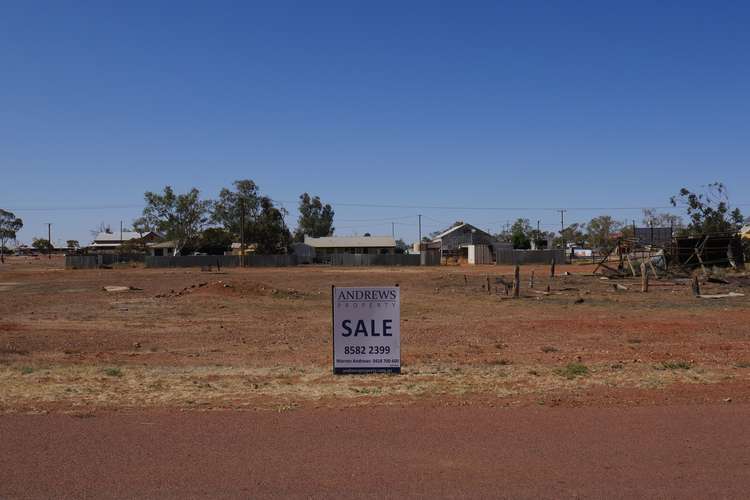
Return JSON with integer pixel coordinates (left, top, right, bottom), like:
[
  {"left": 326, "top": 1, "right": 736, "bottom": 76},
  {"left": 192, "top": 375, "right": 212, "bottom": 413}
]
[{"left": 0, "top": 403, "right": 750, "bottom": 498}]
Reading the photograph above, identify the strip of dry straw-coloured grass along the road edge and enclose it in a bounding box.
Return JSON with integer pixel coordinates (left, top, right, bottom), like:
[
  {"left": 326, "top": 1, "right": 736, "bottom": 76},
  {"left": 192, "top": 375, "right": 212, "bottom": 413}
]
[{"left": 0, "top": 363, "right": 750, "bottom": 411}]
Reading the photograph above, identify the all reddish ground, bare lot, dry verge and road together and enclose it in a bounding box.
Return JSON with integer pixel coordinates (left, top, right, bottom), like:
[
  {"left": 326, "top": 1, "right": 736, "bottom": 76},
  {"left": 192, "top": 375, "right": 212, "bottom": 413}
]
[{"left": 0, "top": 259, "right": 750, "bottom": 498}]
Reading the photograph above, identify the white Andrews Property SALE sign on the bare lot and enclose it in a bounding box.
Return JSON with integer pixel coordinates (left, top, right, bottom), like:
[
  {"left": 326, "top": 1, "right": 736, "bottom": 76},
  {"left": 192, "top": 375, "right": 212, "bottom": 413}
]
[{"left": 332, "top": 286, "right": 401, "bottom": 373}]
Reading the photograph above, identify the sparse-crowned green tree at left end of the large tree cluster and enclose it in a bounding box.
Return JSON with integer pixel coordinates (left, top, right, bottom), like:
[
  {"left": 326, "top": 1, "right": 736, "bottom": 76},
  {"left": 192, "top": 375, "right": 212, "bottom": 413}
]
[{"left": 143, "top": 186, "right": 211, "bottom": 255}]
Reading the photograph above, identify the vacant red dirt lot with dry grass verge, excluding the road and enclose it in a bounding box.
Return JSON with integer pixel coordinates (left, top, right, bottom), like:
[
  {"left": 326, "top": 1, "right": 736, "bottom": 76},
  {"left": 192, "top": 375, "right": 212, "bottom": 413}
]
[{"left": 0, "top": 258, "right": 750, "bottom": 414}]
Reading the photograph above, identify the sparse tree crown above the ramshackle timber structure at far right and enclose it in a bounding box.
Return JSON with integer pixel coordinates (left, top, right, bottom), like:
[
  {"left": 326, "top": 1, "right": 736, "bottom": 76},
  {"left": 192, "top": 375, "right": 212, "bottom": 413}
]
[{"left": 669, "top": 182, "right": 743, "bottom": 236}]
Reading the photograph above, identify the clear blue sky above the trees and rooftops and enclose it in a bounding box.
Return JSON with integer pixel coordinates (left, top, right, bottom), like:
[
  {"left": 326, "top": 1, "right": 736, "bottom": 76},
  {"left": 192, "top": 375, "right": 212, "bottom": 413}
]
[{"left": 0, "top": 0, "right": 750, "bottom": 243}]
